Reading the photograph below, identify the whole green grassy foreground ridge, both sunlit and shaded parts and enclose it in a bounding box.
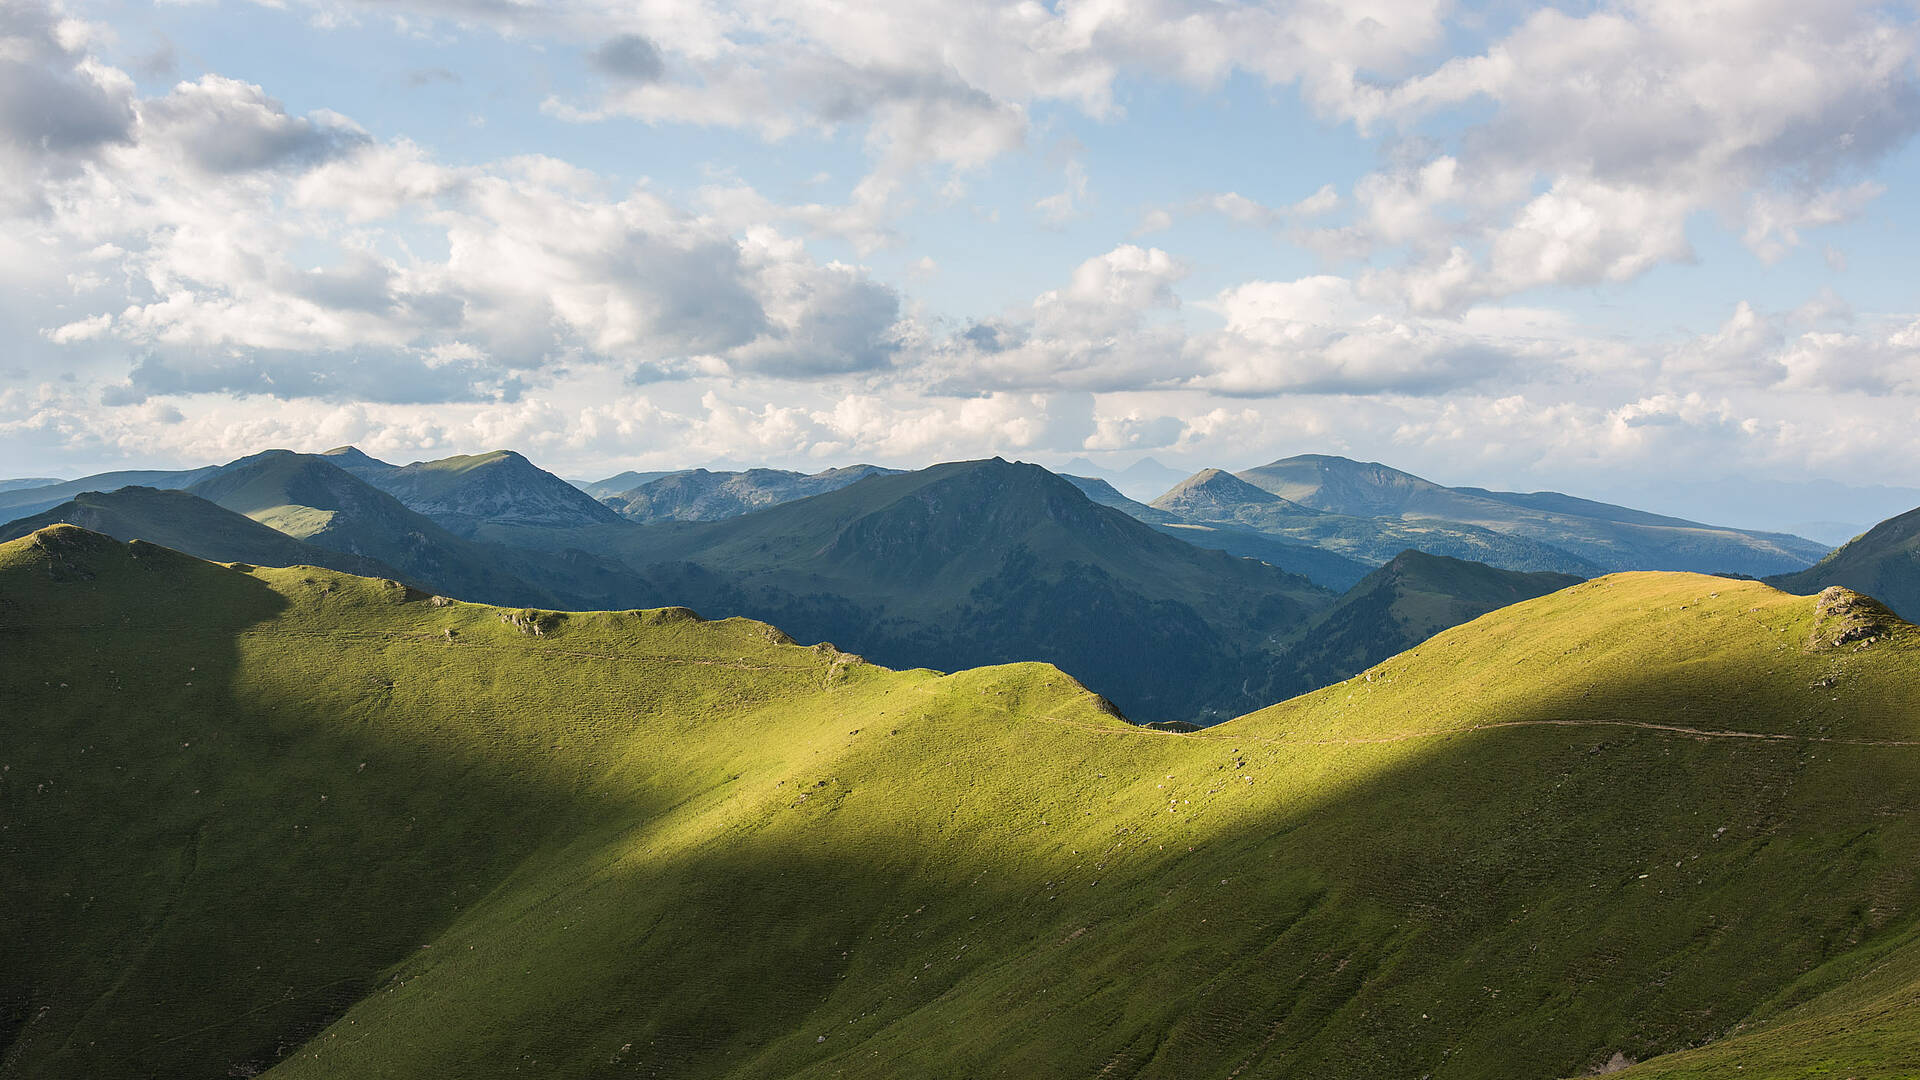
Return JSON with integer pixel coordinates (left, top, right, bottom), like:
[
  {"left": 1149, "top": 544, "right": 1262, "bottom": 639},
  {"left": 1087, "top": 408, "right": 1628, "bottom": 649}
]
[{"left": 0, "top": 528, "right": 1920, "bottom": 1078}]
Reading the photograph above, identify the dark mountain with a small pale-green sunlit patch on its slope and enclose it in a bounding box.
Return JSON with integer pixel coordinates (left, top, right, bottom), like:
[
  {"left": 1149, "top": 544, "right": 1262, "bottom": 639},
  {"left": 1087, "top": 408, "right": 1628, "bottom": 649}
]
[{"left": 190, "top": 450, "right": 605, "bottom": 605}]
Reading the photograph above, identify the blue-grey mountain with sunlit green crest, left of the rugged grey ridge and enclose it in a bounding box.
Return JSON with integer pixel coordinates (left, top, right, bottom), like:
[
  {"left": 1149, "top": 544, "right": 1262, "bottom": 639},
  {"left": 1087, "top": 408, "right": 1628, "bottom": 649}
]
[{"left": 328, "top": 446, "right": 618, "bottom": 536}]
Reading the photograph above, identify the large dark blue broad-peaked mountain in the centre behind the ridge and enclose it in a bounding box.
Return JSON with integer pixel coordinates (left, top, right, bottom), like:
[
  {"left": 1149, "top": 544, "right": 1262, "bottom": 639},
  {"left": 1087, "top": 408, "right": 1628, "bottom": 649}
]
[{"left": 516, "top": 459, "right": 1332, "bottom": 721}]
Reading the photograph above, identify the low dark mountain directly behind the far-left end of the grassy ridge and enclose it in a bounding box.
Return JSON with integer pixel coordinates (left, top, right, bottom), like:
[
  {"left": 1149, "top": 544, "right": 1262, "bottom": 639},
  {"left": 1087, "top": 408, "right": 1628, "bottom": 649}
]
[{"left": 0, "top": 488, "right": 407, "bottom": 578}]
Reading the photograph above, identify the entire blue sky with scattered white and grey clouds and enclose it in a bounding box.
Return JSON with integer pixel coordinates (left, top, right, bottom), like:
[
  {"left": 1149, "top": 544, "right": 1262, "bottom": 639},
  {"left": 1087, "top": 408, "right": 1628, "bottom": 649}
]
[{"left": 0, "top": 0, "right": 1920, "bottom": 517}]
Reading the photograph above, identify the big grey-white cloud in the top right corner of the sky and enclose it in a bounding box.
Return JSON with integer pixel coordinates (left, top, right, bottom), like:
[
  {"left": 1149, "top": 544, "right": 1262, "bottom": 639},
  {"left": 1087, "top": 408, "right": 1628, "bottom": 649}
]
[{"left": 1315, "top": 0, "right": 1920, "bottom": 309}]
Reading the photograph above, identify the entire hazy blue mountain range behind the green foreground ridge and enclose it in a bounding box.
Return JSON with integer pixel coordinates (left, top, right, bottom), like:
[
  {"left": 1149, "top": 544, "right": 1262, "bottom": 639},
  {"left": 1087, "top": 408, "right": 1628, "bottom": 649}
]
[{"left": 0, "top": 448, "right": 1889, "bottom": 724}]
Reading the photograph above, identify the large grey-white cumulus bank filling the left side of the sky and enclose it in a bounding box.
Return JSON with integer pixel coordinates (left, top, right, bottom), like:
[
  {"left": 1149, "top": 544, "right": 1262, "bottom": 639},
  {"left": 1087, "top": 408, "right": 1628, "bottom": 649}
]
[{"left": 0, "top": 8, "right": 908, "bottom": 404}]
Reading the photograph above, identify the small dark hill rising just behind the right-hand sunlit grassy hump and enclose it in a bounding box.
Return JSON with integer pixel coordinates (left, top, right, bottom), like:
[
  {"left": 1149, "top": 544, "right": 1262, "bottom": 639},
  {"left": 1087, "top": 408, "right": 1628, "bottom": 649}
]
[{"left": 1288, "top": 550, "right": 1584, "bottom": 688}]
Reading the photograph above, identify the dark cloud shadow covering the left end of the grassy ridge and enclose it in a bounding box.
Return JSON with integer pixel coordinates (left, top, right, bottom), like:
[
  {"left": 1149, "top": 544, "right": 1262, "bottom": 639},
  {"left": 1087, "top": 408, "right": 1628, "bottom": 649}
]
[{"left": 0, "top": 534, "right": 680, "bottom": 1076}]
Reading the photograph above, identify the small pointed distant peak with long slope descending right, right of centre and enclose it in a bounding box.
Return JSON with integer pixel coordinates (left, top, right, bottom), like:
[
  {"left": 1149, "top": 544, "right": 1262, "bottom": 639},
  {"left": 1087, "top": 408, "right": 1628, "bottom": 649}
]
[{"left": 1152, "top": 469, "right": 1599, "bottom": 577}]
